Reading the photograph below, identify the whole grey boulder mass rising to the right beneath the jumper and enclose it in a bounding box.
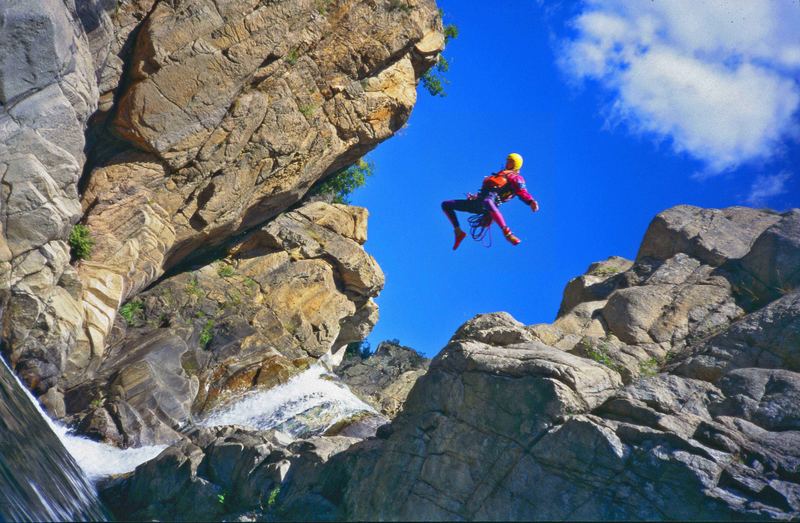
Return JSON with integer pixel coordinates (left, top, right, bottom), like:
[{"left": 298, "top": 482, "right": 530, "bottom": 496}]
[{"left": 103, "top": 206, "right": 800, "bottom": 520}]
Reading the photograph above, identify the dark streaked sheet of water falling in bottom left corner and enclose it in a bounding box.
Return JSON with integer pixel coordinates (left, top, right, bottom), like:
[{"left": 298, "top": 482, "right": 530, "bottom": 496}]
[{"left": 0, "top": 358, "right": 108, "bottom": 521}]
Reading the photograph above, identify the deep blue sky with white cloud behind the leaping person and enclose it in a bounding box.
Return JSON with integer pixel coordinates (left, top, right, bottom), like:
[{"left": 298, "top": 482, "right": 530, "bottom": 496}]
[{"left": 352, "top": 0, "right": 800, "bottom": 356}]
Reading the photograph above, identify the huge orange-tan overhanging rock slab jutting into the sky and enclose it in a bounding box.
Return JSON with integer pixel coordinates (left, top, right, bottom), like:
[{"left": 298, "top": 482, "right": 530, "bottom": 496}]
[{"left": 79, "top": 0, "right": 442, "bottom": 368}]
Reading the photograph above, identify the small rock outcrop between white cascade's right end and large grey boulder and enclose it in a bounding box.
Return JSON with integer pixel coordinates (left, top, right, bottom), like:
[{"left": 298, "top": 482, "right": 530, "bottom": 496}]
[{"left": 335, "top": 341, "right": 430, "bottom": 418}]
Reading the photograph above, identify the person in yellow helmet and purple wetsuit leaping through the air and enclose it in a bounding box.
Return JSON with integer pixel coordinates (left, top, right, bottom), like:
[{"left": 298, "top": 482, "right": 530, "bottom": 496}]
[{"left": 442, "top": 153, "right": 539, "bottom": 250}]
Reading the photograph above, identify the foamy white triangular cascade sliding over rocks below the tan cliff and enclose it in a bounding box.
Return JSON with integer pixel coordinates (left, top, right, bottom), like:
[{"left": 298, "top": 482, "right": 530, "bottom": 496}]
[{"left": 201, "top": 364, "right": 377, "bottom": 437}]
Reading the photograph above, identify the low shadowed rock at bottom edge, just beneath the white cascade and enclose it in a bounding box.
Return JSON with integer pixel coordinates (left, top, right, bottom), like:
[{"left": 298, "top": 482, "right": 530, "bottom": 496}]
[{"left": 102, "top": 427, "right": 356, "bottom": 521}]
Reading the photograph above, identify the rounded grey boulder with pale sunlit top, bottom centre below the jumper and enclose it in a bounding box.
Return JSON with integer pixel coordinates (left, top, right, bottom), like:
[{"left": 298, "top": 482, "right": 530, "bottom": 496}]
[{"left": 347, "top": 341, "right": 621, "bottom": 520}]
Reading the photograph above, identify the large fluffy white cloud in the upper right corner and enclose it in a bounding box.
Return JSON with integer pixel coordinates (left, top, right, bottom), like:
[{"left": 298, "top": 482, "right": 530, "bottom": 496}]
[{"left": 561, "top": 0, "right": 800, "bottom": 174}]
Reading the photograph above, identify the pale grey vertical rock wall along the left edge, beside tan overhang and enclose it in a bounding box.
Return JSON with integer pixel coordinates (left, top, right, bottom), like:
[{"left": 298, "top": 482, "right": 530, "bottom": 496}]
[{"left": 0, "top": 0, "right": 97, "bottom": 394}]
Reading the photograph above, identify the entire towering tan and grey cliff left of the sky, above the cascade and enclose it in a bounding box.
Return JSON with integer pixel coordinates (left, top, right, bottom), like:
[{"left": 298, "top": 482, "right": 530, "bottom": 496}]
[{"left": 0, "top": 0, "right": 444, "bottom": 446}]
